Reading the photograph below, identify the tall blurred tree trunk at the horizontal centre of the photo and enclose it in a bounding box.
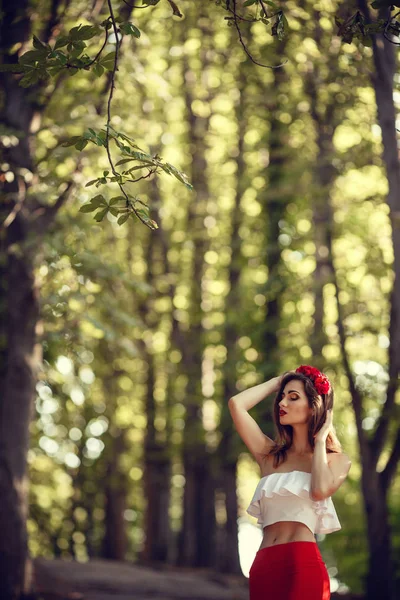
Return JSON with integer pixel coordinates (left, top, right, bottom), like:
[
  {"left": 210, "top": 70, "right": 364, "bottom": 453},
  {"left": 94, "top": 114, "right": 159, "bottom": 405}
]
[{"left": 178, "top": 17, "right": 216, "bottom": 567}]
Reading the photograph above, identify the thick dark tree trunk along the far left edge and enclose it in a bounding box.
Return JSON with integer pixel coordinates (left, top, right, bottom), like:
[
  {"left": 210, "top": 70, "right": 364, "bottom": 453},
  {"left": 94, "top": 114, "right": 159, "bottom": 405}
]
[{"left": 0, "top": 1, "right": 41, "bottom": 600}]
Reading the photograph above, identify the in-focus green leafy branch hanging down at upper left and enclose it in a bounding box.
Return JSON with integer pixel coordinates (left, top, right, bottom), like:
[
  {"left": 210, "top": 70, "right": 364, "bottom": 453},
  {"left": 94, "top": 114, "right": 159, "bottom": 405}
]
[{"left": 0, "top": 0, "right": 189, "bottom": 229}]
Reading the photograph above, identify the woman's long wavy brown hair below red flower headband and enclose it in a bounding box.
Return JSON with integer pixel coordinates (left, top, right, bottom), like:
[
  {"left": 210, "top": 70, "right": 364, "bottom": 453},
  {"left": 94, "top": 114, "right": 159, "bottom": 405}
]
[{"left": 267, "top": 372, "right": 342, "bottom": 469}]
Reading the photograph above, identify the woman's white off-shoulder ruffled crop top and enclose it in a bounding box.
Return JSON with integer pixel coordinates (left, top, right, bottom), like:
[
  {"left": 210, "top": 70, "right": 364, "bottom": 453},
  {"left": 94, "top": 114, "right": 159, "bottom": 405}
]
[{"left": 247, "top": 470, "right": 341, "bottom": 534}]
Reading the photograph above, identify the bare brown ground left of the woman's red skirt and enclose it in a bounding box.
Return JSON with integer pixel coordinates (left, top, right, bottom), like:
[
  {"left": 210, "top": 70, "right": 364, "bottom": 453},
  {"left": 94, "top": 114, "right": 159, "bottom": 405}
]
[{"left": 33, "top": 558, "right": 362, "bottom": 600}]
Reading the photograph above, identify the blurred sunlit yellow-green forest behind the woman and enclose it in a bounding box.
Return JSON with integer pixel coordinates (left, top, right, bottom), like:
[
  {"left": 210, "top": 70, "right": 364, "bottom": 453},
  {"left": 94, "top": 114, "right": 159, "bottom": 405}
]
[{"left": 0, "top": 0, "right": 400, "bottom": 598}]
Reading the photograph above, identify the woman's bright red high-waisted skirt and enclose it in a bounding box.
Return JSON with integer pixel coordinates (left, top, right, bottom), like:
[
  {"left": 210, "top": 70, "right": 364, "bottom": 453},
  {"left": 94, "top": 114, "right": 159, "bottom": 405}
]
[{"left": 249, "top": 542, "right": 331, "bottom": 600}]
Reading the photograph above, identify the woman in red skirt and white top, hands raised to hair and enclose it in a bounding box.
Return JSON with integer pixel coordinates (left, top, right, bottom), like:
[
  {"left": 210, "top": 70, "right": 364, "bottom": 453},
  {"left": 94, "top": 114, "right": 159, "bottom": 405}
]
[{"left": 229, "top": 365, "right": 351, "bottom": 600}]
